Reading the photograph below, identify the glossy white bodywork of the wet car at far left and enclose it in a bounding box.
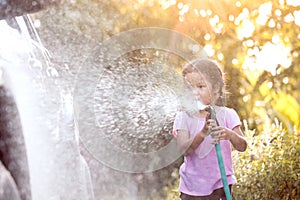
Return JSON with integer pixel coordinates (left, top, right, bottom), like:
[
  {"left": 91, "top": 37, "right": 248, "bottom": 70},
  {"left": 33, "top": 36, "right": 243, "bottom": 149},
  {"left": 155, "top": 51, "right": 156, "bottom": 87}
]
[{"left": 0, "top": 17, "right": 93, "bottom": 200}]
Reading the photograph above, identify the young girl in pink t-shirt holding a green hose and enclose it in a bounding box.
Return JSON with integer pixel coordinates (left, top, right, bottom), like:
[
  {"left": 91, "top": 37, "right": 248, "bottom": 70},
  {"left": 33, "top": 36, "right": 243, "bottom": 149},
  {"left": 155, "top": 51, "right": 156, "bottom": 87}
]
[{"left": 173, "top": 59, "right": 247, "bottom": 200}]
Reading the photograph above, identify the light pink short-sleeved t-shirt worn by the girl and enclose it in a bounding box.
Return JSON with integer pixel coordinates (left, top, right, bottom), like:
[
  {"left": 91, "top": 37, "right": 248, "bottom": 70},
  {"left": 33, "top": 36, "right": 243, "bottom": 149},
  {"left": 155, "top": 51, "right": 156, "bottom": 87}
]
[{"left": 173, "top": 107, "right": 241, "bottom": 196}]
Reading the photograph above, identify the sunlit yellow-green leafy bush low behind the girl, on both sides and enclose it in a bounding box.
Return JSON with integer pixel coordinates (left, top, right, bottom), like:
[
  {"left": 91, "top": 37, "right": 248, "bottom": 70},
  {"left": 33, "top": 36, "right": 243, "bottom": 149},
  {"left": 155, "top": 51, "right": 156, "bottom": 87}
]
[{"left": 163, "top": 120, "right": 300, "bottom": 200}]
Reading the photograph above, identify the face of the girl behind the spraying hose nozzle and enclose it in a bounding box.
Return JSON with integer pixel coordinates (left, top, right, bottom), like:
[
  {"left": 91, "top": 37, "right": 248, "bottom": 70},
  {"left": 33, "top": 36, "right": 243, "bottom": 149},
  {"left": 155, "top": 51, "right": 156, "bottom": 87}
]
[{"left": 185, "top": 72, "right": 216, "bottom": 105}]
